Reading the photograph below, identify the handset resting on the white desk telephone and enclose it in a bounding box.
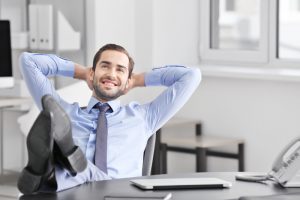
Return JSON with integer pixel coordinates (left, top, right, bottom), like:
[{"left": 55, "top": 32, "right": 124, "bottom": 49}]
[{"left": 269, "top": 137, "right": 300, "bottom": 184}]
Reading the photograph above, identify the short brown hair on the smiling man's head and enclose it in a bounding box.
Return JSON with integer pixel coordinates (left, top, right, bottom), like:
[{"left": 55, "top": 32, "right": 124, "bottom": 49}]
[{"left": 93, "top": 44, "right": 134, "bottom": 78}]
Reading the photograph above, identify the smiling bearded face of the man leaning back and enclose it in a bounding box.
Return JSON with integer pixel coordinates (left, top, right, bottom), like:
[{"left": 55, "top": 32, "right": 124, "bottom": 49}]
[{"left": 90, "top": 50, "right": 129, "bottom": 102}]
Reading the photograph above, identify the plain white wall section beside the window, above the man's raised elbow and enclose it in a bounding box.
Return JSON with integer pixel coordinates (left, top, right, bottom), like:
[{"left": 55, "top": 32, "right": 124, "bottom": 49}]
[{"left": 153, "top": 0, "right": 200, "bottom": 65}]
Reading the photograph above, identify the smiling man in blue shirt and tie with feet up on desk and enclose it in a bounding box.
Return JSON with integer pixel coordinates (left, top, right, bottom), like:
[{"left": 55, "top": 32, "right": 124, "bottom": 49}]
[{"left": 18, "top": 44, "right": 201, "bottom": 193}]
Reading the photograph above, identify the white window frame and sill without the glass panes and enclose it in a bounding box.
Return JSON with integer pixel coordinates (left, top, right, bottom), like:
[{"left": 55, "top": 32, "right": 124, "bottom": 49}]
[{"left": 198, "top": 0, "right": 300, "bottom": 82}]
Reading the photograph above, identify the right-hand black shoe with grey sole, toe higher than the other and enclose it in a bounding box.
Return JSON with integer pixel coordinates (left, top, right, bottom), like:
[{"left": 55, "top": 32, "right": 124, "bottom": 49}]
[{"left": 42, "top": 95, "right": 87, "bottom": 176}]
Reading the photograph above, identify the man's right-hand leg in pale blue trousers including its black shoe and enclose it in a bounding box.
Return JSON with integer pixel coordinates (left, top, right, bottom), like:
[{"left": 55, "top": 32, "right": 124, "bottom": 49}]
[{"left": 42, "top": 95, "right": 110, "bottom": 191}]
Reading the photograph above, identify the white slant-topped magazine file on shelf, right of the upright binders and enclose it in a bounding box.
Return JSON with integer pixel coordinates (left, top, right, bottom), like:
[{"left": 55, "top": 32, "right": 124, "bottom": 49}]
[{"left": 57, "top": 11, "right": 80, "bottom": 51}]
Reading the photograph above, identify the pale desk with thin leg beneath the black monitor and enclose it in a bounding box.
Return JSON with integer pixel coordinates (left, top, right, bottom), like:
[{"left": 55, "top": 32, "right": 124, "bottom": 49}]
[{"left": 0, "top": 96, "right": 32, "bottom": 176}]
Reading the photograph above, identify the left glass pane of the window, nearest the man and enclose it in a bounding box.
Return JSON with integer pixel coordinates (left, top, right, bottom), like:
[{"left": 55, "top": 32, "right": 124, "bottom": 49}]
[{"left": 210, "top": 0, "right": 260, "bottom": 51}]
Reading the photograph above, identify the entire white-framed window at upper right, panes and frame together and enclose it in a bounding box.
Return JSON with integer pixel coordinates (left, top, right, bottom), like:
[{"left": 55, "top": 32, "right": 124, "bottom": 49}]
[{"left": 200, "top": 0, "right": 300, "bottom": 65}]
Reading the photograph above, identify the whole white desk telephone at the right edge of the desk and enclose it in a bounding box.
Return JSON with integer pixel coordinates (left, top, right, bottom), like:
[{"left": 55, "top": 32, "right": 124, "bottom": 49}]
[{"left": 236, "top": 137, "right": 300, "bottom": 187}]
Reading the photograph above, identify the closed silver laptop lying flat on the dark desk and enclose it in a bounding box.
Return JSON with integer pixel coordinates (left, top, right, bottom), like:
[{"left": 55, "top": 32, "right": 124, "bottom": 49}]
[{"left": 130, "top": 178, "right": 232, "bottom": 190}]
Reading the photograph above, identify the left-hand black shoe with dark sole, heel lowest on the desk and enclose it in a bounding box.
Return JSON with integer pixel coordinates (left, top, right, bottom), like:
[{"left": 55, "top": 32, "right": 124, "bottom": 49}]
[{"left": 18, "top": 111, "right": 54, "bottom": 194}]
